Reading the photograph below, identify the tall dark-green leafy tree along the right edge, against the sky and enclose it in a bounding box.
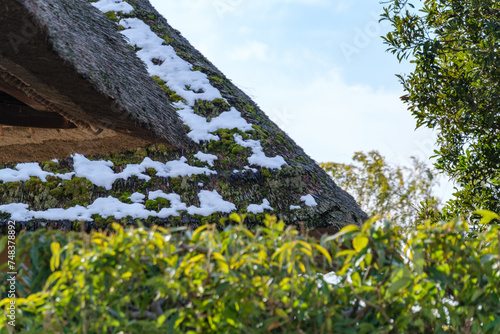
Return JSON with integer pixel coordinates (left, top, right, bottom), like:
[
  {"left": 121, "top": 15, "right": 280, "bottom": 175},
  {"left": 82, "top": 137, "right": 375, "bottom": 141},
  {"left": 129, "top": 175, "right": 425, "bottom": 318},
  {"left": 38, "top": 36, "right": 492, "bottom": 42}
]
[{"left": 382, "top": 0, "right": 500, "bottom": 214}]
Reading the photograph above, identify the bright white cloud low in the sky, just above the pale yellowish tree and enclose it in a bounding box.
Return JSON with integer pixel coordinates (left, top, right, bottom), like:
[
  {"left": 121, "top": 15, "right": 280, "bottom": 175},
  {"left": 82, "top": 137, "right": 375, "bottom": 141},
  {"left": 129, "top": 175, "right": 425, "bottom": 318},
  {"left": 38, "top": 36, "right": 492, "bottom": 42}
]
[{"left": 255, "top": 70, "right": 432, "bottom": 162}]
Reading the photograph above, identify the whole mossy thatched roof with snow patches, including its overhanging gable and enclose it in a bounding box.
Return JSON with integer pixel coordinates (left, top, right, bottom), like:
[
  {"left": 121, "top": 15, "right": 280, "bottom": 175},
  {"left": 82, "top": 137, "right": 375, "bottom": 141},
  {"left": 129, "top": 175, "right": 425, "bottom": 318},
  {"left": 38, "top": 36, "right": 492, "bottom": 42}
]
[{"left": 0, "top": 0, "right": 367, "bottom": 230}]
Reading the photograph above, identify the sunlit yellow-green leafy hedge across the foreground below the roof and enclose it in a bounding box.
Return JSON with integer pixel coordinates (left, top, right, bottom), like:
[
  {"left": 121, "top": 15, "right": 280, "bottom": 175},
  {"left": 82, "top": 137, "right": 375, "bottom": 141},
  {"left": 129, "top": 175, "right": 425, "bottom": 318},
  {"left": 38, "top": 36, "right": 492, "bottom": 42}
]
[{"left": 0, "top": 212, "right": 500, "bottom": 333}]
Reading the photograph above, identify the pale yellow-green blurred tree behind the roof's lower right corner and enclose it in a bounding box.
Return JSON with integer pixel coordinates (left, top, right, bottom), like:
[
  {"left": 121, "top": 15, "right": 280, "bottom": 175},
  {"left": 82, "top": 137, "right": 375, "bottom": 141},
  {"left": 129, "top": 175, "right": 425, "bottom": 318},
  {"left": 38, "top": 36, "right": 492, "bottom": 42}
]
[{"left": 320, "top": 151, "right": 439, "bottom": 223}]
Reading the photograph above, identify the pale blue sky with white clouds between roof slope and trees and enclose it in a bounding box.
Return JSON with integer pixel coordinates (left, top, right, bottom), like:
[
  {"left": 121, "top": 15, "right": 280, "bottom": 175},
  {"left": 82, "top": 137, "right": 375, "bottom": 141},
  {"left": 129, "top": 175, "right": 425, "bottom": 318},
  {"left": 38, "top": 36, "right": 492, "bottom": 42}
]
[{"left": 147, "top": 0, "right": 452, "bottom": 201}]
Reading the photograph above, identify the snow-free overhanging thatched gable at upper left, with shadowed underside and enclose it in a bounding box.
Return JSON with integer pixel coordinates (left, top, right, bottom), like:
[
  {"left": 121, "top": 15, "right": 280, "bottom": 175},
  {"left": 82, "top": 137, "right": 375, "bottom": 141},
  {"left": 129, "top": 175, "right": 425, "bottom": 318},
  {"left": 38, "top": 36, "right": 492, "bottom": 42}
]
[{"left": 0, "top": 0, "right": 187, "bottom": 147}]
